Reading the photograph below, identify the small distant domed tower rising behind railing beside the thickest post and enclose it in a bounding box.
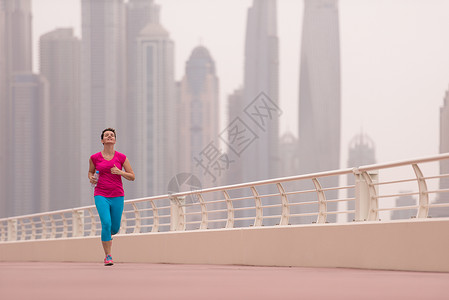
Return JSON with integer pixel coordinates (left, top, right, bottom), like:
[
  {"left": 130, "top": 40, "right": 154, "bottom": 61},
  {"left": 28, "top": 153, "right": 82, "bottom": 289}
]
[{"left": 347, "top": 133, "right": 376, "bottom": 222}]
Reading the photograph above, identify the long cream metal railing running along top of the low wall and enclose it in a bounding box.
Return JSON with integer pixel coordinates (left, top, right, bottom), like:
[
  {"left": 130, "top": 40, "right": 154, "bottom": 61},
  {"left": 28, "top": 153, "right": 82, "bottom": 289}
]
[{"left": 0, "top": 153, "right": 449, "bottom": 242}]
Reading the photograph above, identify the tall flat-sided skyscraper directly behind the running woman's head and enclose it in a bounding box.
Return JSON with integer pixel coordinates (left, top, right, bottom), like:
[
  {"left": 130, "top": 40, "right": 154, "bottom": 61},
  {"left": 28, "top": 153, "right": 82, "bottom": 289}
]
[{"left": 80, "top": 0, "right": 126, "bottom": 204}]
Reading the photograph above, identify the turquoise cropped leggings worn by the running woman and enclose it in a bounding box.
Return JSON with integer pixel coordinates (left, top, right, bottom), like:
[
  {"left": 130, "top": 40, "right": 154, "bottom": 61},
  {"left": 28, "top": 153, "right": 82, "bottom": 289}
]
[{"left": 95, "top": 196, "right": 125, "bottom": 242}]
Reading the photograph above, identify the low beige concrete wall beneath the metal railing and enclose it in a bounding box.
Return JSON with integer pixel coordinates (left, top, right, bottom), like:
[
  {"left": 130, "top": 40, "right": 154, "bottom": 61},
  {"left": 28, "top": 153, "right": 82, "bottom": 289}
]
[{"left": 0, "top": 218, "right": 449, "bottom": 272}]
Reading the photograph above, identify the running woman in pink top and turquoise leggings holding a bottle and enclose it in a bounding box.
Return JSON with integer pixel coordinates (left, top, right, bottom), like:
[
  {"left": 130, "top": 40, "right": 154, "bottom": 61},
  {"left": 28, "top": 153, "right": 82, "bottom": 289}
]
[{"left": 88, "top": 128, "right": 135, "bottom": 266}]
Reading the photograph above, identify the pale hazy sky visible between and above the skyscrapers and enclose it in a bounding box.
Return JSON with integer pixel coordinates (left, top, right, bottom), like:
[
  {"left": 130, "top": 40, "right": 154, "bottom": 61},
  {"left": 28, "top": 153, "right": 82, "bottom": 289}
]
[{"left": 32, "top": 0, "right": 449, "bottom": 173}]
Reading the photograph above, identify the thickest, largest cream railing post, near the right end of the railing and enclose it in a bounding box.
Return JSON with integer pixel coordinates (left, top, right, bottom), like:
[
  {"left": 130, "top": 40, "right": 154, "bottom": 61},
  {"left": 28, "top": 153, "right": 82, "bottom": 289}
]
[{"left": 353, "top": 168, "right": 378, "bottom": 222}]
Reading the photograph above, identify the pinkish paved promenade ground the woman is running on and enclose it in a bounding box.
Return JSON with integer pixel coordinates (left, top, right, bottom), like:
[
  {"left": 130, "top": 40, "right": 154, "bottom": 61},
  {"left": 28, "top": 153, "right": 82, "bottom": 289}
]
[{"left": 0, "top": 262, "right": 449, "bottom": 300}]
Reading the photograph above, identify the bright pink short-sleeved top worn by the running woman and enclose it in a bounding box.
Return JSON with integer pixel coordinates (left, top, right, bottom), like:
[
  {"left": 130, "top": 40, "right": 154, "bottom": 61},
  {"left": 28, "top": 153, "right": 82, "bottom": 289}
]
[{"left": 90, "top": 151, "right": 126, "bottom": 197}]
